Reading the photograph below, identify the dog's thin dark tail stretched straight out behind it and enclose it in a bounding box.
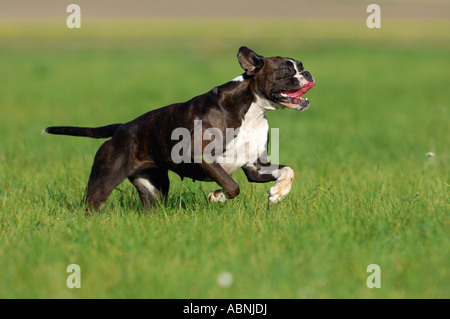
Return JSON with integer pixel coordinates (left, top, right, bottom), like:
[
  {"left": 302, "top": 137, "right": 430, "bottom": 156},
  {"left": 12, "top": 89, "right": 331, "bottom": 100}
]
[{"left": 41, "top": 123, "right": 122, "bottom": 138}]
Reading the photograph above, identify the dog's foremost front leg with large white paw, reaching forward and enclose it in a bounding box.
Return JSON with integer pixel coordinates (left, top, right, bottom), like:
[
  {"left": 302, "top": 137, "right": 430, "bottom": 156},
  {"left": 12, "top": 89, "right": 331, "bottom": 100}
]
[{"left": 242, "top": 161, "right": 294, "bottom": 204}]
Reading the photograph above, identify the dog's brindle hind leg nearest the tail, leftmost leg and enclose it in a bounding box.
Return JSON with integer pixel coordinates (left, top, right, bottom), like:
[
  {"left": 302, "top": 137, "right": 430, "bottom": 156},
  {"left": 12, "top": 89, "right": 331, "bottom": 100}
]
[{"left": 86, "top": 141, "right": 130, "bottom": 210}]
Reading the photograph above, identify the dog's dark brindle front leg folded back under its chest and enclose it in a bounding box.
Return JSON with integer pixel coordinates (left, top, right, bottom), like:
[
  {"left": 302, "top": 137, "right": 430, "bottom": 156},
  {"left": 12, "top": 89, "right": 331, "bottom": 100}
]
[{"left": 199, "top": 162, "right": 239, "bottom": 203}]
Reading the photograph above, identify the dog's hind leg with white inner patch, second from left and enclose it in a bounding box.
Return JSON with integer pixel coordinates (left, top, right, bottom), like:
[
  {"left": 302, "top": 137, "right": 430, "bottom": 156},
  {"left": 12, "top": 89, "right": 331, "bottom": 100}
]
[{"left": 129, "top": 168, "right": 169, "bottom": 210}]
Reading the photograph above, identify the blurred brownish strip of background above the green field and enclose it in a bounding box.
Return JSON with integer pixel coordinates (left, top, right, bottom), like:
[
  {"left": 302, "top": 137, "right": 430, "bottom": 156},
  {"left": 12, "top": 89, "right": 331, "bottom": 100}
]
[{"left": 0, "top": 0, "right": 450, "bottom": 19}]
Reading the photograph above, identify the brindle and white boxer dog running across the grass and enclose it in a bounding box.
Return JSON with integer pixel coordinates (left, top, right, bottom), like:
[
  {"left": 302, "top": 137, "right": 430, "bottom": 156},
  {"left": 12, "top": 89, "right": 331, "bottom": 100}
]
[{"left": 43, "top": 46, "right": 315, "bottom": 210}]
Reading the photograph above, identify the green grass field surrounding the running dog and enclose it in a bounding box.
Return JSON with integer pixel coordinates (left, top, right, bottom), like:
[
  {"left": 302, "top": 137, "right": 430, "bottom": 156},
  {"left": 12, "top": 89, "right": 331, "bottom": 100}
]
[{"left": 0, "top": 20, "right": 450, "bottom": 298}]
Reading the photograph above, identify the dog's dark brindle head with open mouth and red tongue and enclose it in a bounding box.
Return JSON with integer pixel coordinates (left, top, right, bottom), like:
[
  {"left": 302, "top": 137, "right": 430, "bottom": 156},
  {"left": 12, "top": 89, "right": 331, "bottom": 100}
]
[{"left": 238, "top": 47, "right": 316, "bottom": 111}]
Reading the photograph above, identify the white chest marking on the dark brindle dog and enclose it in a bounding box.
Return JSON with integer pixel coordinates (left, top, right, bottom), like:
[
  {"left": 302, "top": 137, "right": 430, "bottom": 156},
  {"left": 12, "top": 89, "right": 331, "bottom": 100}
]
[{"left": 217, "top": 97, "right": 272, "bottom": 175}]
